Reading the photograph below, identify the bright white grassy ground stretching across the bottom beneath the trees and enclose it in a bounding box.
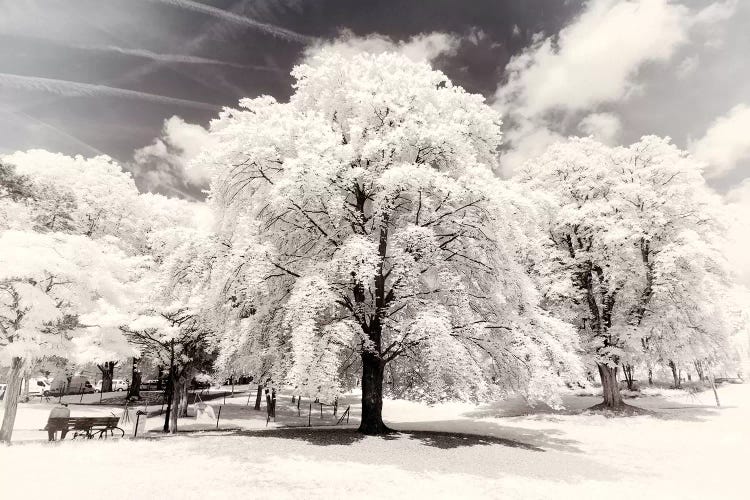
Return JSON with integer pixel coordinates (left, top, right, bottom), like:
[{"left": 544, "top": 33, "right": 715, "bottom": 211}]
[{"left": 0, "top": 384, "right": 750, "bottom": 499}]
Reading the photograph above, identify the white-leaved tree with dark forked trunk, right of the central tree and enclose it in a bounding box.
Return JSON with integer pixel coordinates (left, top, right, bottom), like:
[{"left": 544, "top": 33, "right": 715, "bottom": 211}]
[{"left": 519, "top": 136, "right": 731, "bottom": 407}]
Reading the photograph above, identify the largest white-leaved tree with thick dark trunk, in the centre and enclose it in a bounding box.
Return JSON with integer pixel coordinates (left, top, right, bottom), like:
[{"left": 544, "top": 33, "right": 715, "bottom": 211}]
[{"left": 199, "top": 52, "right": 575, "bottom": 434}]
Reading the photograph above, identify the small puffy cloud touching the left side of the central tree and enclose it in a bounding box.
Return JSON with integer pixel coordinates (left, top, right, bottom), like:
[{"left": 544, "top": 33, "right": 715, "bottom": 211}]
[{"left": 129, "top": 116, "right": 212, "bottom": 199}]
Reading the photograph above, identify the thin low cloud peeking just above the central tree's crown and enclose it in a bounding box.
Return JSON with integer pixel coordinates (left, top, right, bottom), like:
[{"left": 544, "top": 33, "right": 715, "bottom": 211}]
[{"left": 305, "top": 30, "right": 460, "bottom": 61}]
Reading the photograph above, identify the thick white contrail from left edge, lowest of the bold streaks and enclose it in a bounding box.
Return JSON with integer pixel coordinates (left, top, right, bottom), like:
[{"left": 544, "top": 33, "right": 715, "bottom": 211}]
[{"left": 0, "top": 73, "right": 219, "bottom": 111}]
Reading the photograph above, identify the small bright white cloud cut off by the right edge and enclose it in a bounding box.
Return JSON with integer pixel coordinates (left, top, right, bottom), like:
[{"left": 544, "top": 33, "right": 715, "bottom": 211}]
[{"left": 690, "top": 104, "right": 750, "bottom": 177}]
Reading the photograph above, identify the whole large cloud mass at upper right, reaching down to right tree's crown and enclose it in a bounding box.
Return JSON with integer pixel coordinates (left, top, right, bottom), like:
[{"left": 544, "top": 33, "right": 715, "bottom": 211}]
[{"left": 494, "top": 0, "right": 737, "bottom": 174}]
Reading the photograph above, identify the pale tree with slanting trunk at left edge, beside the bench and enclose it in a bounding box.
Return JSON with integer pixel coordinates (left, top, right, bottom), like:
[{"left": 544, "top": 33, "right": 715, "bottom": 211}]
[{"left": 0, "top": 230, "right": 141, "bottom": 442}]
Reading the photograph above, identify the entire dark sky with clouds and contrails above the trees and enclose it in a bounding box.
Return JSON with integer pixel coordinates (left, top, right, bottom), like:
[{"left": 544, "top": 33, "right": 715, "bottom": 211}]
[{"left": 0, "top": 0, "right": 750, "bottom": 213}]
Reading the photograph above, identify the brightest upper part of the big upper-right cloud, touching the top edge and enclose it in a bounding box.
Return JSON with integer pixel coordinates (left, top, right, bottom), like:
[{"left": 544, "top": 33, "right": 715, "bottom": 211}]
[{"left": 498, "top": 0, "right": 690, "bottom": 116}]
